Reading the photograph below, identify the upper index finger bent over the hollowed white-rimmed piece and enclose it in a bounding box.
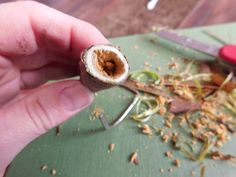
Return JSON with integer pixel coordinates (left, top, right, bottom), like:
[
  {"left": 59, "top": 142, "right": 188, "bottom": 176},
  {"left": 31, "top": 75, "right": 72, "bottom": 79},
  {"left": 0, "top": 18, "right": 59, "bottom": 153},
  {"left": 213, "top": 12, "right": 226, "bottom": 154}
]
[{"left": 0, "top": 1, "right": 109, "bottom": 57}]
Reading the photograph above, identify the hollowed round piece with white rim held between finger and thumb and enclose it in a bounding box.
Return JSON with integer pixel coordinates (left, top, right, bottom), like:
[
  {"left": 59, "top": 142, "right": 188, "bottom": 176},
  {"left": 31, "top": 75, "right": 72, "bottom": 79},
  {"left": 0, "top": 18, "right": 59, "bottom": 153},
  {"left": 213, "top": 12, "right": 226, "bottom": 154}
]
[{"left": 79, "top": 45, "right": 129, "bottom": 92}]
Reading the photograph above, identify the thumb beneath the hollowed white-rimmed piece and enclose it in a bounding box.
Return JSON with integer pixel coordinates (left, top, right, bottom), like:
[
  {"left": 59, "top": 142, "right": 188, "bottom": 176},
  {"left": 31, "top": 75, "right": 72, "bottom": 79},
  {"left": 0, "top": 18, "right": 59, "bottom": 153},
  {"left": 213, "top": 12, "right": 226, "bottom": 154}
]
[{"left": 0, "top": 80, "right": 93, "bottom": 173}]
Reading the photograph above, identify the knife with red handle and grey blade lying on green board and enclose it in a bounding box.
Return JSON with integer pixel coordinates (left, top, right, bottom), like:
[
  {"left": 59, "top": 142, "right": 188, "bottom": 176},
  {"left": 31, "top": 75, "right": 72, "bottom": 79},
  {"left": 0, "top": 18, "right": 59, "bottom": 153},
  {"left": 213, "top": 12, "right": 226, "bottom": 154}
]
[{"left": 156, "top": 30, "right": 236, "bottom": 66}]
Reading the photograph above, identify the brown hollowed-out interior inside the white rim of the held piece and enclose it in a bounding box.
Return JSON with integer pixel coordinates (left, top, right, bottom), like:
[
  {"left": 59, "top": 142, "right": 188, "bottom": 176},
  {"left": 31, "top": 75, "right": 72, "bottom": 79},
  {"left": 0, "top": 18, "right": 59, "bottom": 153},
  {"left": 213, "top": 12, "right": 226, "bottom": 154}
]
[{"left": 94, "top": 50, "right": 125, "bottom": 79}]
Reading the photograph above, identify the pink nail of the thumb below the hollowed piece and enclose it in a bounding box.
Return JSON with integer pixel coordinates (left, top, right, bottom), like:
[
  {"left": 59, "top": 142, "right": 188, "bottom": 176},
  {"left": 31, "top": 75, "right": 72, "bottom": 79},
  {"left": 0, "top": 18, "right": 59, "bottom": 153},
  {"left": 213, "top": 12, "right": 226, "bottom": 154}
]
[{"left": 60, "top": 82, "right": 93, "bottom": 111}]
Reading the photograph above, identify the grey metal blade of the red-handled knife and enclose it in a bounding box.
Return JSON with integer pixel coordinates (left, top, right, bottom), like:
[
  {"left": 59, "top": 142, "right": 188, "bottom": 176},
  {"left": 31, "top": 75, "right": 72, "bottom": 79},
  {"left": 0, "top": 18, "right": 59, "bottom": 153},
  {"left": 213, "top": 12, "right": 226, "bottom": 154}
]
[{"left": 156, "top": 30, "right": 221, "bottom": 57}]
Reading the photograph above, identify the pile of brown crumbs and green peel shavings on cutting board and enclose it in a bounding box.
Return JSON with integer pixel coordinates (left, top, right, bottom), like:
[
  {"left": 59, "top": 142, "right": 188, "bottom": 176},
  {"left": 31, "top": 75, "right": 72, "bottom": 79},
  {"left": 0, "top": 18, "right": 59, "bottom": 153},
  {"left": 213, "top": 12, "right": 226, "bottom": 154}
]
[{"left": 123, "top": 61, "right": 236, "bottom": 176}]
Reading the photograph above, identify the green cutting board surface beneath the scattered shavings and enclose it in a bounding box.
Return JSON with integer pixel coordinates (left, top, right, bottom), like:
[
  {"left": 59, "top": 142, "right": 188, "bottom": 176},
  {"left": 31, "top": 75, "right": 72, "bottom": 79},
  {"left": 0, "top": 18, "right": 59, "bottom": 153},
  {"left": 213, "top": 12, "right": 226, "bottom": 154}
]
[{"left": 6, "top": 24, "right": 236, "bottom": 177}]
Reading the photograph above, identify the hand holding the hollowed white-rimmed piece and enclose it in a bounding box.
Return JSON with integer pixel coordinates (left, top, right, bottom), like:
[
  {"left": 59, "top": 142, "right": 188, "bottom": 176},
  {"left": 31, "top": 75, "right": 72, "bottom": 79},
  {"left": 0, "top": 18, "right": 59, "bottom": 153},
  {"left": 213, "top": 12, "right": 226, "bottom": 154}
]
[{"left": 0, "top": 1, "right": 108, "bottom": 177}]
